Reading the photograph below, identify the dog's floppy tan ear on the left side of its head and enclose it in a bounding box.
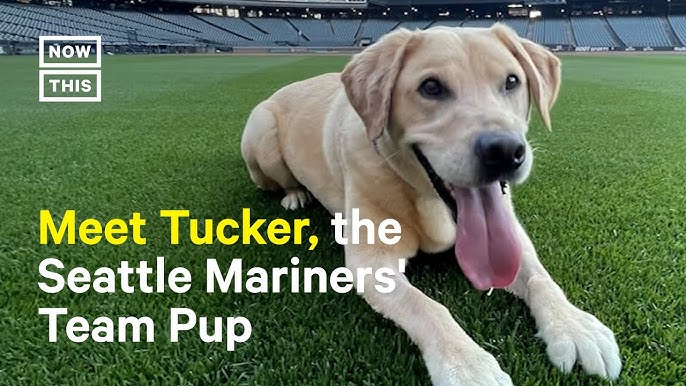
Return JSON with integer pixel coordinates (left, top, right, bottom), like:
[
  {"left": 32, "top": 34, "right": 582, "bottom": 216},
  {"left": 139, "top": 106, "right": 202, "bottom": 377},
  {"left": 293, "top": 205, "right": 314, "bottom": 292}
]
[{"left": 341, "top": 28, "right": 413, "bottom": 141}]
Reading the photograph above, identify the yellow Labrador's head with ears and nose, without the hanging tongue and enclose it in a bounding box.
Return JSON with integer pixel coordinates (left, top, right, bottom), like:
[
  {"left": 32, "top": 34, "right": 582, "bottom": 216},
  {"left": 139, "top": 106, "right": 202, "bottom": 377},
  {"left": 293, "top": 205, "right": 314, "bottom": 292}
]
[{"left": 341, "top": 24, "right": 560, "bottom": 187}]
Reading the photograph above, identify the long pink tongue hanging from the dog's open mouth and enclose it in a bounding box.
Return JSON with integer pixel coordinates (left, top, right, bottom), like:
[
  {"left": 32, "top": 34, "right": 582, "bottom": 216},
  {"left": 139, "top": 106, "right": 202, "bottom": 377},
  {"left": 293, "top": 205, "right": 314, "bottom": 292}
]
[{"left": 452, "top": 182, "right": 522, "bottom": 290}]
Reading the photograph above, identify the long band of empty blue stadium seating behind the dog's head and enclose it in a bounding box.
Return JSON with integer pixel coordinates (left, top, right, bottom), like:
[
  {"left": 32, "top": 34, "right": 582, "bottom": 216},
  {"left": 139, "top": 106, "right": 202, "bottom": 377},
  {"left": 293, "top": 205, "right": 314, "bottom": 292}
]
[{"left": 0, "top": 3, "right": 686, "bottom": 49}]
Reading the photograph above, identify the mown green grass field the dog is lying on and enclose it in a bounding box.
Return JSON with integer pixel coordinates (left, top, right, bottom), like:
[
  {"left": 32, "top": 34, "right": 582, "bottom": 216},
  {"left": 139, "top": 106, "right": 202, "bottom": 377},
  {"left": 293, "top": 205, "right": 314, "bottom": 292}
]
[{"left": 0, "top": 55, "right": 686, "bottom": 385}]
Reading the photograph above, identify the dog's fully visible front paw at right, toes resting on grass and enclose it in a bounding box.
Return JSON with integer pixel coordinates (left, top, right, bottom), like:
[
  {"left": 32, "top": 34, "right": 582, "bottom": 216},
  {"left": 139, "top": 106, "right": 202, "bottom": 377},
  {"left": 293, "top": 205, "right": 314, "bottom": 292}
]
[{"left": 537, "top": 305, "right": 622, "bottom": 379}]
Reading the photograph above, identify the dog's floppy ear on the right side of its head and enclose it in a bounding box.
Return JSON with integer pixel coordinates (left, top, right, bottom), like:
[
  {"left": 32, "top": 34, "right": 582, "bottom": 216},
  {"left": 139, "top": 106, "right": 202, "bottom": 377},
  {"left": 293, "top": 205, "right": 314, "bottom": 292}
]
[{"left": 493, "top": 24, "right": 561, "bottom": 129}]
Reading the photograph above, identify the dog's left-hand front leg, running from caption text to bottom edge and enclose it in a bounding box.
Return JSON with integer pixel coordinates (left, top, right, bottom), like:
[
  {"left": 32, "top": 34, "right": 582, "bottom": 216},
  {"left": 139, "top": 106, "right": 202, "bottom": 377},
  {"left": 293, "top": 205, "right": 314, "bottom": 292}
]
[{"left": 345, "top": 241, "right": 512, "bottom": 386}]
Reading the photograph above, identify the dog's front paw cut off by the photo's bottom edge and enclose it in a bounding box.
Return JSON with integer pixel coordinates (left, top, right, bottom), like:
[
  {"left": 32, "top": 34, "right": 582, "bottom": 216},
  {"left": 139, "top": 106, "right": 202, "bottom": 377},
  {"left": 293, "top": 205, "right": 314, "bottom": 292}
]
[{"left": 426, "top": 344, "right": 512, "bottom": 386}]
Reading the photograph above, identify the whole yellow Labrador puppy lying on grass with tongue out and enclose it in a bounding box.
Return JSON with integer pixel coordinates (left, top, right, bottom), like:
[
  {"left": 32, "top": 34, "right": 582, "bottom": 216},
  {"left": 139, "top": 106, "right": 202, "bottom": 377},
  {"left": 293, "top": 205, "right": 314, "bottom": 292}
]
[{"left": 241, "top": 25, "right": 621, "bottom": 386}]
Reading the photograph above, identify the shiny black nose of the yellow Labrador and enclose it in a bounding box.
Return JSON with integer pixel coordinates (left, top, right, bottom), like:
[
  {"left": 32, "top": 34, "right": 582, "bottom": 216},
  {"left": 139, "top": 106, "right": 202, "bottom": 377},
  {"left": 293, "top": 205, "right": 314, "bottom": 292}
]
[{"left": 475, "top": 132, "right": 526, "bottom": 176}]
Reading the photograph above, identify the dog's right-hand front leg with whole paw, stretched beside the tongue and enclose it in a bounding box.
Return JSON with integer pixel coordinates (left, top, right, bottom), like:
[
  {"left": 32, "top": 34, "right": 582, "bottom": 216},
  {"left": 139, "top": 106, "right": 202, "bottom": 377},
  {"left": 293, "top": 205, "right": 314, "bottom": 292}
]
[{"left": 508, "top": 217, "right": 622, "bottom": 379}]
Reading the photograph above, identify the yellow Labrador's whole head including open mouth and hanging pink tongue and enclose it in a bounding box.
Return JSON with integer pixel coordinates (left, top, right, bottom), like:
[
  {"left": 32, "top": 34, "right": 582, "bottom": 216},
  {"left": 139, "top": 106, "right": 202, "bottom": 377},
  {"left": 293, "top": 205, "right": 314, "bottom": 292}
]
[{"left": 341, "top": 25, "right": 560, "bottom": 289}]
